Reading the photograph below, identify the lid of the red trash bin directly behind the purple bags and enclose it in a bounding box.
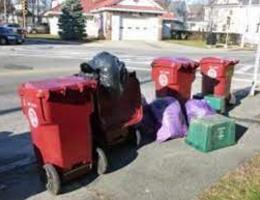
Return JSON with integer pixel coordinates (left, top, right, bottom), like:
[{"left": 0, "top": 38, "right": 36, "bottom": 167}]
[{"left": 151, "top": 57, "right": 199, "bottom": 70}]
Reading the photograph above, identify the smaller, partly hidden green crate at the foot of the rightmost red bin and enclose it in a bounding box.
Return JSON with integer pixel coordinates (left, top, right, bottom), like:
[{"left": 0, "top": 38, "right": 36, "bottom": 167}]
[{"left": 204, "top": 95, "right": 226, "bottom": 113}]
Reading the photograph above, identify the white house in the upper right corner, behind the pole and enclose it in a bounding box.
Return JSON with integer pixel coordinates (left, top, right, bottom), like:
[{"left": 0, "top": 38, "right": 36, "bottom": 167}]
[{"left": 204, "top": 0, "right": 260, "bottom": 43}]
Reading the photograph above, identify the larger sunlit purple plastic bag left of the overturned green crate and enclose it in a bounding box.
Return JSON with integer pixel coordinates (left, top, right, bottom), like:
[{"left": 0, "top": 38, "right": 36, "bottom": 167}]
[{"left": 156, "top": 101, "right": 188, "bottom": 142}]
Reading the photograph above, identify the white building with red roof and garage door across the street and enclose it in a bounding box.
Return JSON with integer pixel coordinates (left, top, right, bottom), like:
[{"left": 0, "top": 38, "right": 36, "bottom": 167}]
[{"left": 45, "top": 0, "right": 165, "bottom": 40}]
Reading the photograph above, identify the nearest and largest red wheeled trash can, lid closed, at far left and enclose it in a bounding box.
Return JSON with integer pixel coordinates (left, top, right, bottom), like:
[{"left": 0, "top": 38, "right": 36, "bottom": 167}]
[{"left": 19, "top": 76, "right": 105, "bottom": 194}]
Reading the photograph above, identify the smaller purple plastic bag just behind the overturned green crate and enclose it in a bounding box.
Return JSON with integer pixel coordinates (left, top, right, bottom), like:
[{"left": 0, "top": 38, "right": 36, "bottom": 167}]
[{"left": 185, "top": 99, "right": 216, "bottom": 123}]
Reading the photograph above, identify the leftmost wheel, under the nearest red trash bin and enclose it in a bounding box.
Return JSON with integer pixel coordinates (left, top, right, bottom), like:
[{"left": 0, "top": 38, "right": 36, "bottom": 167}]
[{"left": 43, "top": 164, "right": 61, "bottom": 195}]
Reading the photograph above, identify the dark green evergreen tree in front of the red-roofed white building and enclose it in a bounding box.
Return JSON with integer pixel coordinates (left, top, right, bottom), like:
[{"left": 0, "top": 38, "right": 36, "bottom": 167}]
[{"left": 58, "top": 0, "right": 86, "bottom": 40}]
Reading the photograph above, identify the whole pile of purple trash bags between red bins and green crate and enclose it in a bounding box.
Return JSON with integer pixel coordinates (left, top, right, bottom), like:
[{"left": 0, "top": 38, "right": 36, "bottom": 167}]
[{"left": 139, "top": 97, "right": 216, "bottom": 142}]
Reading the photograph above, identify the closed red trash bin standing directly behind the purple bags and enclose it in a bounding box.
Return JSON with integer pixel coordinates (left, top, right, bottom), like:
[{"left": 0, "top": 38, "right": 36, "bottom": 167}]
[{"left": 152, "top": 57, "right": 199, "bottom": 103}]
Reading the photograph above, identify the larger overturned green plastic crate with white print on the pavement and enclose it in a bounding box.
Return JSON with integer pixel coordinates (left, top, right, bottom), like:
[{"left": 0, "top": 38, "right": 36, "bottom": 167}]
[{"left": 185, "top": 114, "right": 236, "bottom": 152}]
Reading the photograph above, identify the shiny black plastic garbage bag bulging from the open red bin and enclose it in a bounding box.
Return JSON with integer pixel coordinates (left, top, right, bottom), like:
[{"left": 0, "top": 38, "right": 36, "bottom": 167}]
[{"left": 80, "top": 52, "right": 128, "bottom": 95}]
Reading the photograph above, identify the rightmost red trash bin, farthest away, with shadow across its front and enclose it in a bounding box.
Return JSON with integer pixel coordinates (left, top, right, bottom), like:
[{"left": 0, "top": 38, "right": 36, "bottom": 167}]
[{"left": 200, "top": 57, "right": 239, "bottom": 98}]
